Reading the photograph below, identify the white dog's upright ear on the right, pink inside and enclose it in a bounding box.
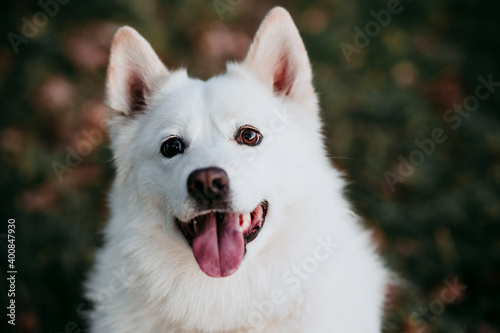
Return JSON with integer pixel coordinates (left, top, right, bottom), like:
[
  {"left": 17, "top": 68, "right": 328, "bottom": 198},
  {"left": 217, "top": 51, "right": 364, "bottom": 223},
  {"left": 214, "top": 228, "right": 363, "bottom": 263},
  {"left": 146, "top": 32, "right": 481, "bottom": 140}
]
[{"left": 243, "top": 7, "right": 315, "bottom": 106}]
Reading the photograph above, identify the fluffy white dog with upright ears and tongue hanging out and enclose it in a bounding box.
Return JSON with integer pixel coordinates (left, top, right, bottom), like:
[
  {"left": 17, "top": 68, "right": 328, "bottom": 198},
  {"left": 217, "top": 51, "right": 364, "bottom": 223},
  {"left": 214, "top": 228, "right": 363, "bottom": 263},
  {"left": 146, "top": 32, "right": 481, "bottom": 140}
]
[{"left": 87, "top": 8, "right": 389, "bottom": 333}]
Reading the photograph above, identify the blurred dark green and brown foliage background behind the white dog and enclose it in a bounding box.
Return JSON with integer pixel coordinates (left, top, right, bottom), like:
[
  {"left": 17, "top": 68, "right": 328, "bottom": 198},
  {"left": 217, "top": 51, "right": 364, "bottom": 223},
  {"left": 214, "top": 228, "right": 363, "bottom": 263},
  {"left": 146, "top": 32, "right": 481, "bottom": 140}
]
[{"left": 0, "top": 0, "right": 500, "bottom": 333}]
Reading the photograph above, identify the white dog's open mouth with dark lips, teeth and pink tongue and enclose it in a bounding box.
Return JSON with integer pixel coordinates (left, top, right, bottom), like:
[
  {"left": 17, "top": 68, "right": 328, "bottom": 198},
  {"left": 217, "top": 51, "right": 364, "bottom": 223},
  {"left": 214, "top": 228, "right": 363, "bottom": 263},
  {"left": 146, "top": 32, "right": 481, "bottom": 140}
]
[{"left": 175, "top": 200, "right": 268, "bottom": 277}]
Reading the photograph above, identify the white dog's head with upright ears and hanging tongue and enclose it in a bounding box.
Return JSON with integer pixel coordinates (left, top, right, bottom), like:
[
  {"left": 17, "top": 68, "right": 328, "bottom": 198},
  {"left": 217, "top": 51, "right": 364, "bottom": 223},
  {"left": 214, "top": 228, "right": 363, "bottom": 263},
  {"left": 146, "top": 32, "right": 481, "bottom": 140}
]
[{"left": 107, "top": 8, "right": 323, "bottom": 277}]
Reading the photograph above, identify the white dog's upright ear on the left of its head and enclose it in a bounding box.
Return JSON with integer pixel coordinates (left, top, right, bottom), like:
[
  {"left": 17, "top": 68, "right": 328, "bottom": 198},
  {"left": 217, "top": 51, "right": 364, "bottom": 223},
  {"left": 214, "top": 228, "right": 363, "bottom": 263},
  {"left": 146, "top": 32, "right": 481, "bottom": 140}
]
[{"left": 106, "top": 26, "right": 168, "bottom": 118}]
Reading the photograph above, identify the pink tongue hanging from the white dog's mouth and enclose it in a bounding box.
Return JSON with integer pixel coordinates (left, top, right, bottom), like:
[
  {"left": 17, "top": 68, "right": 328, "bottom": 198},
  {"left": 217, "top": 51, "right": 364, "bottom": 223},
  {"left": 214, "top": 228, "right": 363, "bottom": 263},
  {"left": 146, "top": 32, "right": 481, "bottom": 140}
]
[{"left": 193, "top": 213, "right": 245, "bottom": 277}]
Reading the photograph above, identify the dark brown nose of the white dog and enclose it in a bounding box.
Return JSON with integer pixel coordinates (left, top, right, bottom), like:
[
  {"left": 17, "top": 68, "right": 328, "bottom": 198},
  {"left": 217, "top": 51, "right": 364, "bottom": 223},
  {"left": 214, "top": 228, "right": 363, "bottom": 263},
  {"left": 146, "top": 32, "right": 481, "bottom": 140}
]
[{"left": 187, "top": 167, "right": 229, "bottom": 208}]
